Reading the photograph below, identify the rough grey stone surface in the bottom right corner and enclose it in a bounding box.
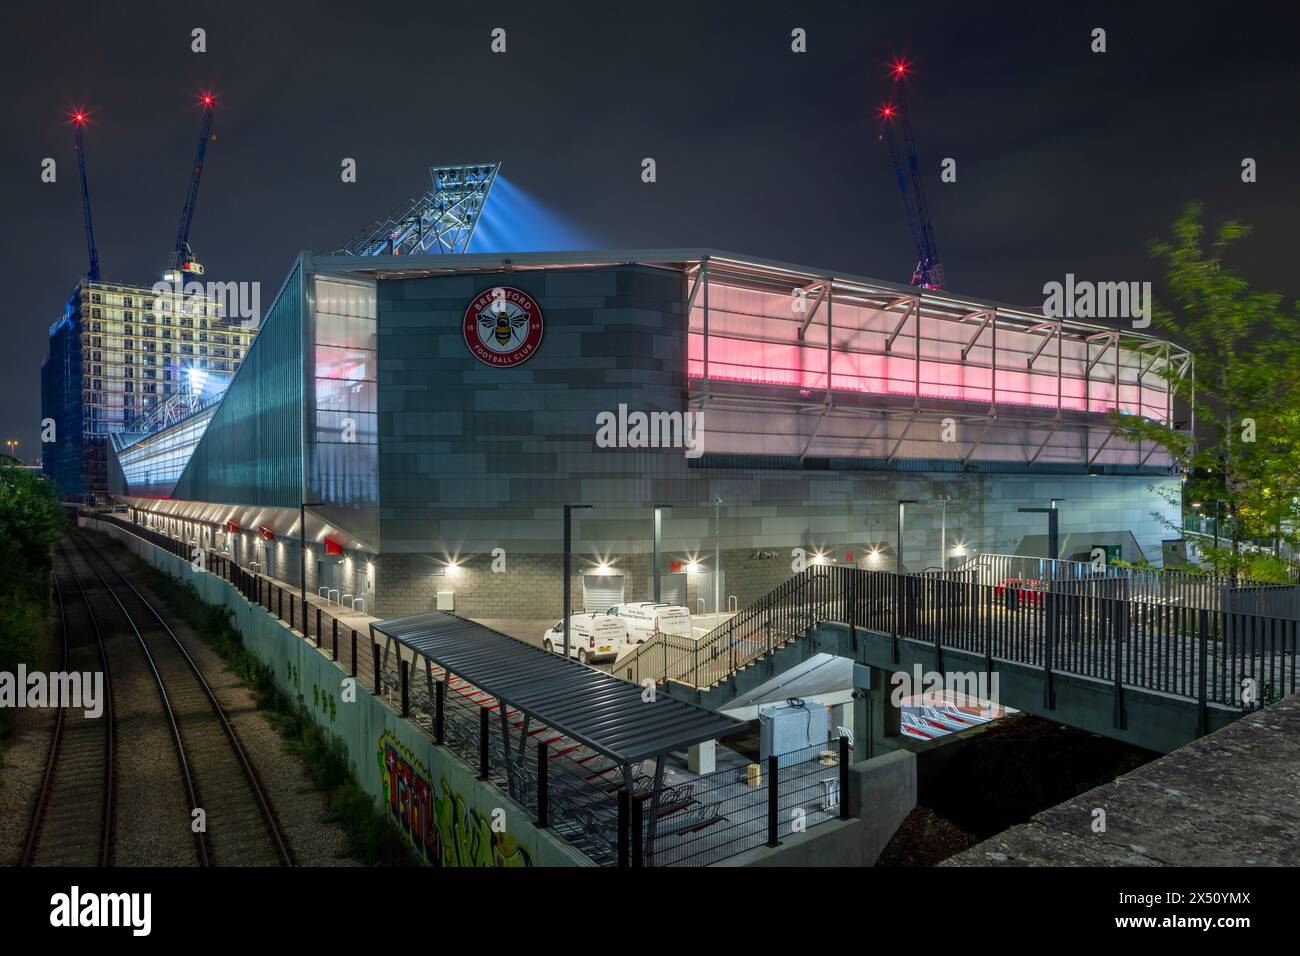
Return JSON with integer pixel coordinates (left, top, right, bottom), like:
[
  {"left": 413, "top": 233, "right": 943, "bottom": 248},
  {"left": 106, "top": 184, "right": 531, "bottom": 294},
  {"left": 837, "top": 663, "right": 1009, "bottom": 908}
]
[{"left": 941, "top": 695, "right": 1300, "bottom": 866}]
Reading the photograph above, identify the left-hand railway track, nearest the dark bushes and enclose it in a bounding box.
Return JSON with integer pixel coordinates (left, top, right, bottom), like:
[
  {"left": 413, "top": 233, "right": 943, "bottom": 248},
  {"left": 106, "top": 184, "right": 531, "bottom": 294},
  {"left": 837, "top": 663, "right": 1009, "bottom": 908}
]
[{"left": 20, "top": 548, "right": 117, "bottom": 866}]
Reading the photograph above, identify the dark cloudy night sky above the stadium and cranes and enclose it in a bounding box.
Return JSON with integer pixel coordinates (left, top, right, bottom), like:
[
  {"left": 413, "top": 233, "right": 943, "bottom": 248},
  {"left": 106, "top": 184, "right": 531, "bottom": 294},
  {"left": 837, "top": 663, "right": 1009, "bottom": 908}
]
[{"left": 0, "top": 0, "right": 1300, "bottom": 458}]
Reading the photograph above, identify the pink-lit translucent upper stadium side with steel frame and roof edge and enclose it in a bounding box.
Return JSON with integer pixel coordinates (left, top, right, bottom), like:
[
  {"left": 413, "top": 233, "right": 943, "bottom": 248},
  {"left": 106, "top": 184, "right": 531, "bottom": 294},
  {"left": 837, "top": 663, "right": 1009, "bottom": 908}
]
[{"left": 332, "top": 250, "right": 1193, "bottom": 473}]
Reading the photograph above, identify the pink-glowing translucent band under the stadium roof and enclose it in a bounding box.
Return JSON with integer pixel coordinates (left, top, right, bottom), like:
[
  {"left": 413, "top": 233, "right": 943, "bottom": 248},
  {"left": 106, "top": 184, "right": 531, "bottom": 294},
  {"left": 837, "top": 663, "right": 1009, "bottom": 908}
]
[{"left": 688, "top": 280, "right": 1167, "bottom": 421}]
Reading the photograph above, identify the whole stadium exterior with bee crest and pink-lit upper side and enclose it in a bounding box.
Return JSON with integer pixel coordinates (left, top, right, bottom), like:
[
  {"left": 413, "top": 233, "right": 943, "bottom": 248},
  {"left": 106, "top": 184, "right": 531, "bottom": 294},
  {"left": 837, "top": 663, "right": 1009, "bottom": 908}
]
[{"left": 111, "top": 250, "right": 1193, "bottom": 619}]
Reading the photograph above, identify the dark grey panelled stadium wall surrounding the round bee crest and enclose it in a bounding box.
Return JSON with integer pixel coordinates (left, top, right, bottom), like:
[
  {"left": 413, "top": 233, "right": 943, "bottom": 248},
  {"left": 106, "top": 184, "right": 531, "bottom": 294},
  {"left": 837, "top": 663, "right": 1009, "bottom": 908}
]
[{"left": 380, "top": 267, "right": 686, "bottom": 515}]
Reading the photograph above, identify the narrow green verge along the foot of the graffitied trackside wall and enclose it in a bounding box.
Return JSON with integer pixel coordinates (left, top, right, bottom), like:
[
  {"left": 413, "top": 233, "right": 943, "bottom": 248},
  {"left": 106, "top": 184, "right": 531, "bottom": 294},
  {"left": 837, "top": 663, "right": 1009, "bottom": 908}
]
[{"left": 92, "top": 532, "right": 415, "bottom": 866}]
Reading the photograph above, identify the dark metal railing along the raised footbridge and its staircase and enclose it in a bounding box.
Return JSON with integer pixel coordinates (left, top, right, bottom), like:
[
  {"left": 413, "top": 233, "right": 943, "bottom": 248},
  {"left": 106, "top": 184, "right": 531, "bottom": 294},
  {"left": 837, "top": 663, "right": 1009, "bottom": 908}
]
[{"left": 616, "top": 567, "right": 1300, "bottom": 708}]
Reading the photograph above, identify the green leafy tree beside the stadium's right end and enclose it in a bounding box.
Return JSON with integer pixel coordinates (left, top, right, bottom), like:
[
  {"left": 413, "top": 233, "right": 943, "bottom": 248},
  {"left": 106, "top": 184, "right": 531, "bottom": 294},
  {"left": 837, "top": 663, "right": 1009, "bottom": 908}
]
[{"left": 1113, "top": 203, "right": 1300, "bottom": 572}]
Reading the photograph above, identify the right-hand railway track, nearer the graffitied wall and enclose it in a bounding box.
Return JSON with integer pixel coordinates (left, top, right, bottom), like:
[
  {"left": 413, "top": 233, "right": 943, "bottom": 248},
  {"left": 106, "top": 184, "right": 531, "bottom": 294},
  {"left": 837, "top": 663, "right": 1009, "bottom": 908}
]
[{"left": 69, "top": 531, "right": 294, "bottom": 866}]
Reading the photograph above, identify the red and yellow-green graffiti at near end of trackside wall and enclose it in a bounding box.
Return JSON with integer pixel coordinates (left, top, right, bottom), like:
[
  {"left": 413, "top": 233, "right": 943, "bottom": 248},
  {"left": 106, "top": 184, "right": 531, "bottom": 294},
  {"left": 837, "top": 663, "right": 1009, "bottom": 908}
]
[{"left": 378, "top": 731, "right": 533, "bottom": 866}]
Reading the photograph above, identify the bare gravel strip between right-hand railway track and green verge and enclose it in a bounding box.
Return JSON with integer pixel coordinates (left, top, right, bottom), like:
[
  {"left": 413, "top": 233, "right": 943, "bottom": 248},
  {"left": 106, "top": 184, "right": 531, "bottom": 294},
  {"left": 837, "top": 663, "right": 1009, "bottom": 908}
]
[{"left": 104, "top": 550, "right": 359, "bottom": 866}]
